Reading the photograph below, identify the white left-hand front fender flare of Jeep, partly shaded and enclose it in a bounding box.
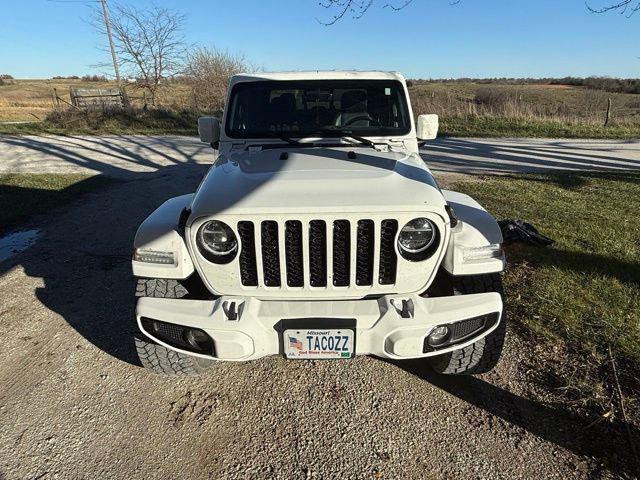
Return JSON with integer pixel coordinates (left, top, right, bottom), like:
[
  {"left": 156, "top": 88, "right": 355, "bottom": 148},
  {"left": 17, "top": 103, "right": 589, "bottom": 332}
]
[{"left": 131, "top": 194, "right": 195, "bottom": 280}]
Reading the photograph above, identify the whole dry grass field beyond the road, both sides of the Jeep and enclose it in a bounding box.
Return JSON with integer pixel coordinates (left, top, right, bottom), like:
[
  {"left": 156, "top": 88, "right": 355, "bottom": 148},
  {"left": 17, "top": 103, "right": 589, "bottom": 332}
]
[{"left": 0, "top": 80, "right": 640, "bottom": 139}]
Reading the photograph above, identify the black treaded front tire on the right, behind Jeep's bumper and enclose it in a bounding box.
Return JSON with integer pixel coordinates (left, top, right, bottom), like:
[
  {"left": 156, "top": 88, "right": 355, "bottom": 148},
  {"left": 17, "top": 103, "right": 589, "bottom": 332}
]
[{"left": 429, "top": 273, "right": 507, "bottom": 375}]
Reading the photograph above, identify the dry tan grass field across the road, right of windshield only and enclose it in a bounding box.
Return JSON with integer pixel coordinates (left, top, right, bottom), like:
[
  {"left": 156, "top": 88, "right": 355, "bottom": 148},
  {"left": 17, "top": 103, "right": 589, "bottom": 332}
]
[{"left": 409, "top": 82, "right": 640, "bottom": 138}]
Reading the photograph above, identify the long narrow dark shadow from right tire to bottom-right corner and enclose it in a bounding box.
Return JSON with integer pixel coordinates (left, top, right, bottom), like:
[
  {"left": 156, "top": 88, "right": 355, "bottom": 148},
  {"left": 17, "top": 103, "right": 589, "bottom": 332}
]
[{"left": 390, "top": 360, "right": 640, "bottom": 478}]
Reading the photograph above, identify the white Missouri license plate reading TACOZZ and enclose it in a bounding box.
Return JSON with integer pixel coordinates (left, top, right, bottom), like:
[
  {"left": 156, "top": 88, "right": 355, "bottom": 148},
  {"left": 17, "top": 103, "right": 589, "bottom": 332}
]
[{"left": 284, "top": 328, "right": 354, "bottom": 359}]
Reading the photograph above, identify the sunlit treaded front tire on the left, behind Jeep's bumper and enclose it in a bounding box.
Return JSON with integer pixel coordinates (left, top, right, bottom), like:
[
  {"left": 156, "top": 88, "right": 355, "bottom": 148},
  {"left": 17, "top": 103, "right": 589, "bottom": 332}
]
[{"left": 135, "top": 278, "right": 213, "bottom": 375}]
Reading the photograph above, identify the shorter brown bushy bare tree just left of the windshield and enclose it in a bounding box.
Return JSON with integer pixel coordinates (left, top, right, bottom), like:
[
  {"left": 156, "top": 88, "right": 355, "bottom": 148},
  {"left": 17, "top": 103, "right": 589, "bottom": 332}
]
[{"left": 184, "top": 47, "right": 253, "bottom": 114}]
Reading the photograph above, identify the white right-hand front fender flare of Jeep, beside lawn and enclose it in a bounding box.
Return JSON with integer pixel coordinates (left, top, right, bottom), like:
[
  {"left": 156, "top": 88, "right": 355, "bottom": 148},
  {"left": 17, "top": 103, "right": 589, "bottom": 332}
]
[{"left": 442, "top": 190, "right": 505, "bottom": 275}]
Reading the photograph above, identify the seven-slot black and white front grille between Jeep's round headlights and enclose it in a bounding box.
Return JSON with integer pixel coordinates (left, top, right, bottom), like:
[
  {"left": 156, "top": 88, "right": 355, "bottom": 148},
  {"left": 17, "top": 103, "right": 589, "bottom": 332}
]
[{"left": 237, "top": 219, "right": 398, "bottom": 289}]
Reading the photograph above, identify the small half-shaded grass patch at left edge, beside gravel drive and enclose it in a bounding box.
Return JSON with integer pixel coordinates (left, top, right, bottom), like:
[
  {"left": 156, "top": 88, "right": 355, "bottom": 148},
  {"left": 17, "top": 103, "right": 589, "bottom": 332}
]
[{"left": 0, "top": 174, "right": 114, "bottom": 234}]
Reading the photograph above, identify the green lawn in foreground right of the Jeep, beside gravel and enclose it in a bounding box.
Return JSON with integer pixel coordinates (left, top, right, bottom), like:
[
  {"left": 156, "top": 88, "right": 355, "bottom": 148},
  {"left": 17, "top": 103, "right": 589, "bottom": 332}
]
[{"left": 457, "top": 173, "right": 640, "bottom": 410}]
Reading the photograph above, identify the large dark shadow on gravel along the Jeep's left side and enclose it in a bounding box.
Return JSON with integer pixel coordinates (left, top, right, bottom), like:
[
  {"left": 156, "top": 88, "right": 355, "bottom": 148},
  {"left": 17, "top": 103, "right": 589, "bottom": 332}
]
[{"left": 0, "top": 165, "right": 207, "bottom": 365}]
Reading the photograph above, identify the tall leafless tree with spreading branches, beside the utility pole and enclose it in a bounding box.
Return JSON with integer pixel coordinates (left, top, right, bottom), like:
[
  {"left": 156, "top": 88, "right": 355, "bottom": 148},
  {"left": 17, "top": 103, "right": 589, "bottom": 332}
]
[{"left": 90, "top": 4, "right": 186, "bottom": 105}]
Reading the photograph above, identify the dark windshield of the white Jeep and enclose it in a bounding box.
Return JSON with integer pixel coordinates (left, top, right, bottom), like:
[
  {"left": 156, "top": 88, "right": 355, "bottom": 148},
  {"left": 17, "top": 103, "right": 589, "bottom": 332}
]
[{"left": 225, "top": 80, "right": 411, "bottom": 138}]
